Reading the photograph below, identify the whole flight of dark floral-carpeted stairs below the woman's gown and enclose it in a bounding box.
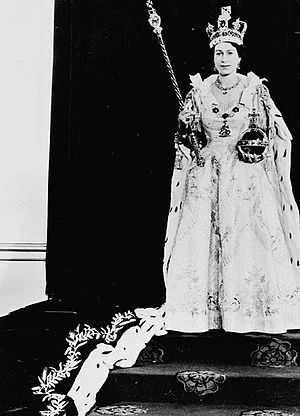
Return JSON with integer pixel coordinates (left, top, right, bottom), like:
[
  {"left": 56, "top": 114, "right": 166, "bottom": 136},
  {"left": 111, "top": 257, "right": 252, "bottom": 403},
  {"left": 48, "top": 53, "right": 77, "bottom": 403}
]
[{"left": 91, "top": 331, "right": 300, "bottom": 416}]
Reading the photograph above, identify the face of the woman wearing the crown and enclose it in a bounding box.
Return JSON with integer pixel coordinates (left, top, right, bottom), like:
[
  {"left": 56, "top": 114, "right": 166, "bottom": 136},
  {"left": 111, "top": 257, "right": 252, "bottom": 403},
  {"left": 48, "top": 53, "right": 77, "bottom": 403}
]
[{"left": 214, "top": 42, "right": 241, "bottom": 75}]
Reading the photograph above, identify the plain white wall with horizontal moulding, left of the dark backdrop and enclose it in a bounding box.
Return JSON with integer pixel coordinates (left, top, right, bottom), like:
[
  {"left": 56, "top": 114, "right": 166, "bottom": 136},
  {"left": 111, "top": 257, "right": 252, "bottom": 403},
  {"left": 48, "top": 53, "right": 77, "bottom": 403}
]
[{"left": 0, "top": 0, "right": 54, "bottom": 315}]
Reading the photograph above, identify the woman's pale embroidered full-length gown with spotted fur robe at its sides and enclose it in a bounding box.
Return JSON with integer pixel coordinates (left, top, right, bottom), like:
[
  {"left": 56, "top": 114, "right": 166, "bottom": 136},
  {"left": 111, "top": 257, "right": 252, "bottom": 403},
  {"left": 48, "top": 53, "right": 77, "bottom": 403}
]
[{"left": 164, "top": 73, "right": 300, "bottom": 333}]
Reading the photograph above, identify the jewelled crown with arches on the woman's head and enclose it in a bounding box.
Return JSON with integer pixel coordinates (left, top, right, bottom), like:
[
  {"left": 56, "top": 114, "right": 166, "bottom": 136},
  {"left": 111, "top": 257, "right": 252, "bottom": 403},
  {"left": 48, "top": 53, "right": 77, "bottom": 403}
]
[{"left": 206, "top": 6, "right": 247, "bottom": 48}]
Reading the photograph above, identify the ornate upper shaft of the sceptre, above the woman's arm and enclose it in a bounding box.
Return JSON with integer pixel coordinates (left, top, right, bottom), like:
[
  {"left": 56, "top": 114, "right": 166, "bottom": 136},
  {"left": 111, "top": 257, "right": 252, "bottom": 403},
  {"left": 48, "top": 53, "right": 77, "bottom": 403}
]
[{"left": 146, "top": 0, "right": 183, "bottom": 108}]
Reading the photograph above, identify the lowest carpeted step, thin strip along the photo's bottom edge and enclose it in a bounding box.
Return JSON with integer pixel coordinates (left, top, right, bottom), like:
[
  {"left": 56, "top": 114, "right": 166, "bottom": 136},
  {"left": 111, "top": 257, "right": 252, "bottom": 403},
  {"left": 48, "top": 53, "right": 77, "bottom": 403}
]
[{"left": 89, "top": 402, "right": 300, "bottom": 416}]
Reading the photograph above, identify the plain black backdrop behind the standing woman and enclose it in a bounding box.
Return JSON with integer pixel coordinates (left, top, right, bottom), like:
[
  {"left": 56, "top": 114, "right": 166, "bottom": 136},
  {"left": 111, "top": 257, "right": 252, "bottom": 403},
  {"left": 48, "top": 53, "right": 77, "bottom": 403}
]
[{"left": 46, "top": 0, "right": 300, "bottom": 310}]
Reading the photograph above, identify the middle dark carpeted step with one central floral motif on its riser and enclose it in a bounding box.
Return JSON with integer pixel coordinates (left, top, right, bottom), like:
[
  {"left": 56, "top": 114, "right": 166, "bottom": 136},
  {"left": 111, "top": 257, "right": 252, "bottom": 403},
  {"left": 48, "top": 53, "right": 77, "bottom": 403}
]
[{"left": 97, "top": 361, "right": 300, "bottom": 407}]
